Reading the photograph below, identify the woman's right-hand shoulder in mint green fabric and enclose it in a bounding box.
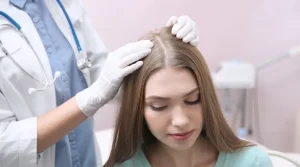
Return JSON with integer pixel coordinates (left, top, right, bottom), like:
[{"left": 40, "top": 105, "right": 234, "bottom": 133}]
[{"left": 223, "top": 146, "right": 273, "bottom": 167}]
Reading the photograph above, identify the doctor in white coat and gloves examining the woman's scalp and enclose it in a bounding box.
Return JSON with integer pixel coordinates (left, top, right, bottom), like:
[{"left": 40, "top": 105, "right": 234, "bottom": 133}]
[{"left": 0, "top": 0, "right": 202, "bottom": 167}]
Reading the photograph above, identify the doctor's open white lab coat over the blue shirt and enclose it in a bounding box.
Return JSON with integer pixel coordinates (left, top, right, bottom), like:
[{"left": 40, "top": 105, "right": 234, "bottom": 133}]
[{"left": 0, "top": 0, "right": 107, "bottom": 167}]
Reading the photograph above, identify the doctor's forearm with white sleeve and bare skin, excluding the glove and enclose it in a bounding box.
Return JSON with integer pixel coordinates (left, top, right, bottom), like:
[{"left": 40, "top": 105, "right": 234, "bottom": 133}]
[{"left": 0, "top": 92, "right": 87, "bottom": 167}]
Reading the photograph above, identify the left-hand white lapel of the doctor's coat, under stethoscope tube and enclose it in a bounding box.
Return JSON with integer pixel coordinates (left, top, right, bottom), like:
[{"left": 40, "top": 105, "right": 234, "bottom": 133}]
[{"left": 0, "top": 1, "right": 52, "bottom": 83}]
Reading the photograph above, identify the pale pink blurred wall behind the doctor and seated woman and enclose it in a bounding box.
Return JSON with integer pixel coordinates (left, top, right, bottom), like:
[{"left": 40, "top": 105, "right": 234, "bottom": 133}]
[{"left": 84, "top": 0, "right": 300, "bottom": 152}]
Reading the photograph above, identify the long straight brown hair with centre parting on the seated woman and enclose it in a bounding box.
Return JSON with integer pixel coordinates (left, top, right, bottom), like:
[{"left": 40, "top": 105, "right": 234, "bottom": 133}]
[{"left": 104, "top": 28, "right": 250, "bottom": 167}]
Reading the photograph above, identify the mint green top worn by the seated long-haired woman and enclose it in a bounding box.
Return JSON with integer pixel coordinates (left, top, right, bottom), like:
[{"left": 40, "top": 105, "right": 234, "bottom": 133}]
[{"left": 114, "top": 146, "right": 273, "bottom": 167}]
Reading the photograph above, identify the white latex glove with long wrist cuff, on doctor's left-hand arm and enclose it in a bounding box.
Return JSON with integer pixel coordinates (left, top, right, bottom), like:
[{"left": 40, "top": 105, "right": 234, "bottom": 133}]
[{"left": 75, "top": 40, "right": 153, "bottom": 117}]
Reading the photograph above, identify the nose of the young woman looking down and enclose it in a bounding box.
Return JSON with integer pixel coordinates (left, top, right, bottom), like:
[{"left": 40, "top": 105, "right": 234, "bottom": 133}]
[{"left": 172, "top": 106, "right": 190, "bottom": 128}]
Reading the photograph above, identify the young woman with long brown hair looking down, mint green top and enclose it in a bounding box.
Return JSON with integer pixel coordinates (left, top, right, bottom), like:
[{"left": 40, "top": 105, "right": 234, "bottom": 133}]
[{"left": 105, "top": 28, "right": 272, "bottom": 167}]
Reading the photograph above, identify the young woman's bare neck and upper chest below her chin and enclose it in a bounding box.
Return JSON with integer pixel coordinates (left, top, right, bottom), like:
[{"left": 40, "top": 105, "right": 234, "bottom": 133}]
[{"left": 148, "top": 138, "right": 218, "bottom": 167}]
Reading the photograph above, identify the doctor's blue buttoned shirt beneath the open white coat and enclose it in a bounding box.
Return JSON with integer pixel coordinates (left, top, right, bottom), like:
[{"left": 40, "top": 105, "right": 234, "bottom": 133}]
[{"left": 10, "top": 0, "right": 96, "bottom": 167}]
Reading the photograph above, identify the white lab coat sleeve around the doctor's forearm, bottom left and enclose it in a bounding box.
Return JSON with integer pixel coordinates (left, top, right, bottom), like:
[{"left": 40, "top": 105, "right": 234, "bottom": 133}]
[{"left": 0, "top": 91, "right": 37, "bottom": 167}]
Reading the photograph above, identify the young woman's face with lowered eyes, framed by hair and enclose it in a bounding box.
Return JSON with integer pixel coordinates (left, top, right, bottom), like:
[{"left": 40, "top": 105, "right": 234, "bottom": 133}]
[{"left": 144, "top": 67, "right": 203, "bottom": 150}]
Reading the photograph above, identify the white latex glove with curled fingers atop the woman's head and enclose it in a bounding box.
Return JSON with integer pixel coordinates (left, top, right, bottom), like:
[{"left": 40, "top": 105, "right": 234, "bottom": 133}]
[{"left": 166, "top": 16, "right": 199, "bottom": 47}]
